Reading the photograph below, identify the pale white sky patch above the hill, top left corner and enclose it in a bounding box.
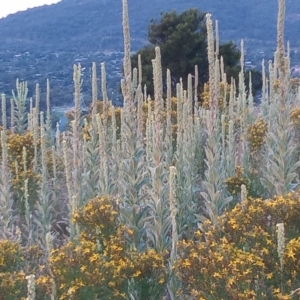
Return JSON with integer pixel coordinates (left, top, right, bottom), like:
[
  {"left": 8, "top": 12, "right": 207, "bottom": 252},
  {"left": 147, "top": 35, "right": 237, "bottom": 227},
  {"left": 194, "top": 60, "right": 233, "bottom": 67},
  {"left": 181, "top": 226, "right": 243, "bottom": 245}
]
[{"left": 0, "top": 0, "right": 60, "bottom": 18}]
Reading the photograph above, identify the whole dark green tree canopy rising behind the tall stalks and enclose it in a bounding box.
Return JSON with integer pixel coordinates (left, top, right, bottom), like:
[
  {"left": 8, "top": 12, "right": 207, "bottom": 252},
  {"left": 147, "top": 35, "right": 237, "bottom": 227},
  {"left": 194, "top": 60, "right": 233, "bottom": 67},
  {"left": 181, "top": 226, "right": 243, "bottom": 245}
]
[{"left": 131, "top": 8, "right": 260, "bottom": 95}]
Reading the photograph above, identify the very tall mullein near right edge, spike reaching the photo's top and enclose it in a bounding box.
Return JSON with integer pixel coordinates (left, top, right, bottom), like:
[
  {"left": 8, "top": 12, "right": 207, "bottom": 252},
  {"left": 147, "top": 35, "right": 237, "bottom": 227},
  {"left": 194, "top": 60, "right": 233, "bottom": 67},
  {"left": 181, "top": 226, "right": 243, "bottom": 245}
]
[{"left": 261, "top": 0, "right": 300, "bottom": 197}]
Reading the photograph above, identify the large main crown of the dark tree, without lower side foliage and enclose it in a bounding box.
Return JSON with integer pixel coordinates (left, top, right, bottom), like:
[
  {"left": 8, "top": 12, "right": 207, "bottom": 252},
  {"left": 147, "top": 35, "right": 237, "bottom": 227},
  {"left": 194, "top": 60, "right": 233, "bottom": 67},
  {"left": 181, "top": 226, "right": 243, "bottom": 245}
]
[{"left": 148, "top": 9, "right": 208, "bottom": 86}]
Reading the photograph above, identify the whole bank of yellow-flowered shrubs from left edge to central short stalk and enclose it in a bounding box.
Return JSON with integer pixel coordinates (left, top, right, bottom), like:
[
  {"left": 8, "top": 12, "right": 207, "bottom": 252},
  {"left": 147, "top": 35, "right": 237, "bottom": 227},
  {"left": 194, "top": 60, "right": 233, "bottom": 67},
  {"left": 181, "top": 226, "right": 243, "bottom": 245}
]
[{"left": 0, "top": 196, "right": 167, "bottom": 300}]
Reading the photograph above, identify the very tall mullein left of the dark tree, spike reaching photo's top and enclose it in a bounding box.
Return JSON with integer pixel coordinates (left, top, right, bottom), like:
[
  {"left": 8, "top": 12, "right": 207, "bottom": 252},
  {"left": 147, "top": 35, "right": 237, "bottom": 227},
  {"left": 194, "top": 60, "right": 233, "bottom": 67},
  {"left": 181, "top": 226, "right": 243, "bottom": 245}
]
[{"left": 117, "top": 0, "right": 151, "bottom": 250}]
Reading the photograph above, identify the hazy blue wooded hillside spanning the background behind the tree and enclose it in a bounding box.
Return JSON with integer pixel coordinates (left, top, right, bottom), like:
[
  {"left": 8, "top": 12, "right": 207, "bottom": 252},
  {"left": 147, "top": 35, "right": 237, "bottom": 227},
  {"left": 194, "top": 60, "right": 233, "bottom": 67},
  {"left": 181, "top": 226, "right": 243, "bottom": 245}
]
[{"left": 0, "top": 0, "right": 300, "bottom": 106}]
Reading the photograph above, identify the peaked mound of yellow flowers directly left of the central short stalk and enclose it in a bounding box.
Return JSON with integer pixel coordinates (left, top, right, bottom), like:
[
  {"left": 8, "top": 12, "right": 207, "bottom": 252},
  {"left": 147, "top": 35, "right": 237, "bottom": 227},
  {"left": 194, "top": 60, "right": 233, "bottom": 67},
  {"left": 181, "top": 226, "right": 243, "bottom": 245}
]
[{"left": 42, "top": 196, "right": 166, "bottom": 299}]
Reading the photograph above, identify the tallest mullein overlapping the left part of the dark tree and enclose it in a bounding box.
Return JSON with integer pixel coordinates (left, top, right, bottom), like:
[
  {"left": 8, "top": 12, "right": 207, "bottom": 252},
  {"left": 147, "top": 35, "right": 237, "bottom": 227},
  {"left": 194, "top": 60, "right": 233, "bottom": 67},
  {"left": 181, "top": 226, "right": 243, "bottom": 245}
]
[{"left": 146, "top": 47, "right": 171, "bottom": 253}]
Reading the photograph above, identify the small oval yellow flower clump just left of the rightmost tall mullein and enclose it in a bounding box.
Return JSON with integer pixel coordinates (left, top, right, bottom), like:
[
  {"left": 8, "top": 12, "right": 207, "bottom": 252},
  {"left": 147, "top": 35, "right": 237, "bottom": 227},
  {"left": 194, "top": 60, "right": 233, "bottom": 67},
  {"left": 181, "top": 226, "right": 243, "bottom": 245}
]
[{"left": 247, "top": 118, "right": 268, "bottom": 151}]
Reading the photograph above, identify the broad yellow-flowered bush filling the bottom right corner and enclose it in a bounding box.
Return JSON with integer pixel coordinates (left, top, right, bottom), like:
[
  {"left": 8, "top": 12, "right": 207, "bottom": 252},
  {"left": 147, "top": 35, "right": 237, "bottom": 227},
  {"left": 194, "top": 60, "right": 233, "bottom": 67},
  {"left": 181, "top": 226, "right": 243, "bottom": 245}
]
[{"left": 175, "top": 193, "right": 300, "bottom": 300}]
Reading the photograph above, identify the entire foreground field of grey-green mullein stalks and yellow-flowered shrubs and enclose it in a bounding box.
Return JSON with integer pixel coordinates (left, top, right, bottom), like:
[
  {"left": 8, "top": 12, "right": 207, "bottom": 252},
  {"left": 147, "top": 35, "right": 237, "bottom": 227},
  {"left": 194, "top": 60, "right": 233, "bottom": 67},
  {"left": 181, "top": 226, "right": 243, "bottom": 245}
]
[{"left": 0, "top": 0, "right": 300, "bottom": 300}]
